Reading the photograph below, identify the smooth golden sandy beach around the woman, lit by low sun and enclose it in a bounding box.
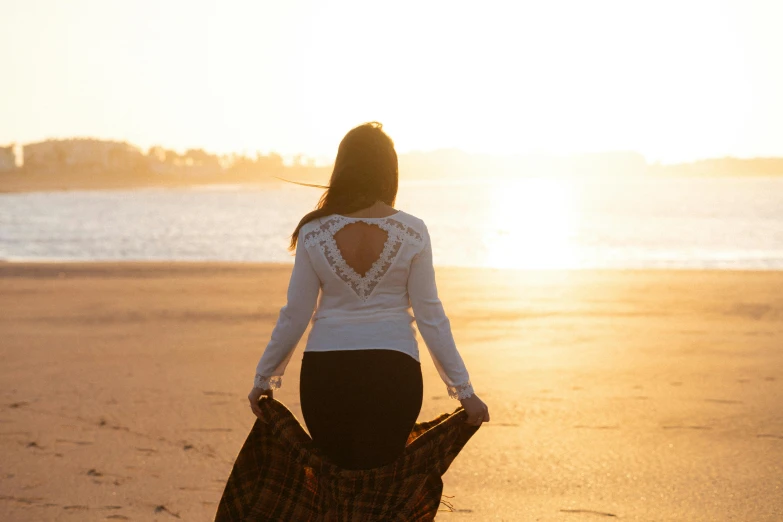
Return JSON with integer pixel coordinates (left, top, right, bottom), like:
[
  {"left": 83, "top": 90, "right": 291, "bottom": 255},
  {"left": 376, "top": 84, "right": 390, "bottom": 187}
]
[{"left": 0, "top": 263, "right": 783, "bottom": 521}]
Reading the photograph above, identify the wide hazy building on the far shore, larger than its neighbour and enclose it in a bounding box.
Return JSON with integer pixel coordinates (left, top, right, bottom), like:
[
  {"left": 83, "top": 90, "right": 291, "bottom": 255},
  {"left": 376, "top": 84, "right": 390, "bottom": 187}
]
[{"left": 23, "top": 139, "right": 144, "bottom": 171}]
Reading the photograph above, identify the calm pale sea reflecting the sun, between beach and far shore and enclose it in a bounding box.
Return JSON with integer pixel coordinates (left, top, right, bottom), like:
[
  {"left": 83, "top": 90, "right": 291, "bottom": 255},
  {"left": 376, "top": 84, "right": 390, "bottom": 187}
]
[{"left": 0, "top": 177, "right": 783, "bottom": 270}]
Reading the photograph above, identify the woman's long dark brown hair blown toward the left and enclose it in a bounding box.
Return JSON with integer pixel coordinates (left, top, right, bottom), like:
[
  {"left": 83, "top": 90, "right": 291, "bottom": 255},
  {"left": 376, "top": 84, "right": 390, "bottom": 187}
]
[{"left": 289, "top": 121, "right": 399, "bottom": 250}]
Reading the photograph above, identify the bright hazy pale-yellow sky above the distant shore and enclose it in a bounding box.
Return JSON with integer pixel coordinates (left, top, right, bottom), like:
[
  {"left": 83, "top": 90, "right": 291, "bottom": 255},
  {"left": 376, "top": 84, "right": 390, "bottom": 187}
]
[{"left": 0, "top": 0, "right": 783, "bottom": 161}]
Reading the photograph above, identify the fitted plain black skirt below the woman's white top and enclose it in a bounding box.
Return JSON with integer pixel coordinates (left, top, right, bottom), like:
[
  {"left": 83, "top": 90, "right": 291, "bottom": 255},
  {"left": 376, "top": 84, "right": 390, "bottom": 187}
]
[{"left": 299, "top": 350, "right": 423, "bottom": 469}]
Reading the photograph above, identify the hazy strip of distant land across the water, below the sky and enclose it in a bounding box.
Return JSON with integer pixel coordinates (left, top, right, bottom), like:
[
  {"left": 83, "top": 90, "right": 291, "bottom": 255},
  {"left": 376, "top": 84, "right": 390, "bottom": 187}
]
[{"left": 6, "top": 138, "right": 783, "bottom": 193}]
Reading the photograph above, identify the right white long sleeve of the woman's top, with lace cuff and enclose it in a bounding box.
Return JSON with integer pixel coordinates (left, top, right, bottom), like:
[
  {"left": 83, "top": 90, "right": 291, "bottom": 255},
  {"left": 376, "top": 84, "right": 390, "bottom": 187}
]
[{"left": 408, "top": 225, "right": 473, "bottom": 399}]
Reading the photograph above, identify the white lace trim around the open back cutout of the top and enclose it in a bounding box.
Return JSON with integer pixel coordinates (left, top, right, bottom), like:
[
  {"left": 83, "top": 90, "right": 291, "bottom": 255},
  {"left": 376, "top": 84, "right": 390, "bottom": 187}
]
[{"left": 304, "top": 216, "right": 424, "bottom": 301}]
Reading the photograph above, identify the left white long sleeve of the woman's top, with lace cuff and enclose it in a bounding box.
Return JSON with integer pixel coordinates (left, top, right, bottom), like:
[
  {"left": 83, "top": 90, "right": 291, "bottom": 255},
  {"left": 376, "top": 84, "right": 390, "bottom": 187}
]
[{"left": 253, "top": 234, "right": 321, "bottom": 389}]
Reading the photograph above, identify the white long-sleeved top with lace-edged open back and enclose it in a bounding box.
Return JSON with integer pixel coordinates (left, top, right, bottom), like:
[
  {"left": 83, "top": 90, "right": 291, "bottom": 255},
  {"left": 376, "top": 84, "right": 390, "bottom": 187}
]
[{"left": 254, "top": 211, "right": 473, "bottom": 399}]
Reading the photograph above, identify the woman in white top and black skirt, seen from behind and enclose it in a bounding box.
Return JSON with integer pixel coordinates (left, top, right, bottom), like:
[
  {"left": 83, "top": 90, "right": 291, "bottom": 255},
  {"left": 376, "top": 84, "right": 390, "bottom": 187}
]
[{"left": 248, "top": 122, "right": 489, "bottom": 470}]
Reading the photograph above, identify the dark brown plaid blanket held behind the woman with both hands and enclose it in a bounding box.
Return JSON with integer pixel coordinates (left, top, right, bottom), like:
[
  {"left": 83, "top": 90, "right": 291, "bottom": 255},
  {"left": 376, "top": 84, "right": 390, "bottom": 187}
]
[{"left": 215, "top": 397, "right": 478, "bottom": 522}]
